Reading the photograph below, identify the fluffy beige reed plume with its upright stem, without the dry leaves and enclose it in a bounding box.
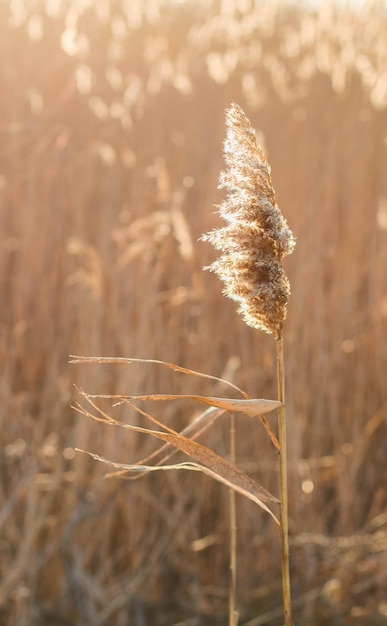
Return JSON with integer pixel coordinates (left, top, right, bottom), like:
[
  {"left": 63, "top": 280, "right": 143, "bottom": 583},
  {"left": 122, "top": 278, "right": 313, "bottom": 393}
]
[{"left": 203, "top": 104, "right": 295, "bottom": 626}]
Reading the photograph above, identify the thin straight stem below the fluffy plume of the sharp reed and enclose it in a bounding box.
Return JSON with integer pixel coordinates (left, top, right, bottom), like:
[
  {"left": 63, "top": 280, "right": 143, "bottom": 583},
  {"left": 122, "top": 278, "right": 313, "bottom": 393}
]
[{"left": 277, "top": 336, "right": 292, "bottom": 626}]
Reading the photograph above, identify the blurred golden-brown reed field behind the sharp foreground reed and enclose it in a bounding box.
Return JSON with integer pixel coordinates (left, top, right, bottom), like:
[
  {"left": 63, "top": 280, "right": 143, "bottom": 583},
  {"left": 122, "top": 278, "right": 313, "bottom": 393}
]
[{"left": 0, "top": 0, "right": 387, "bottom": 626}]
